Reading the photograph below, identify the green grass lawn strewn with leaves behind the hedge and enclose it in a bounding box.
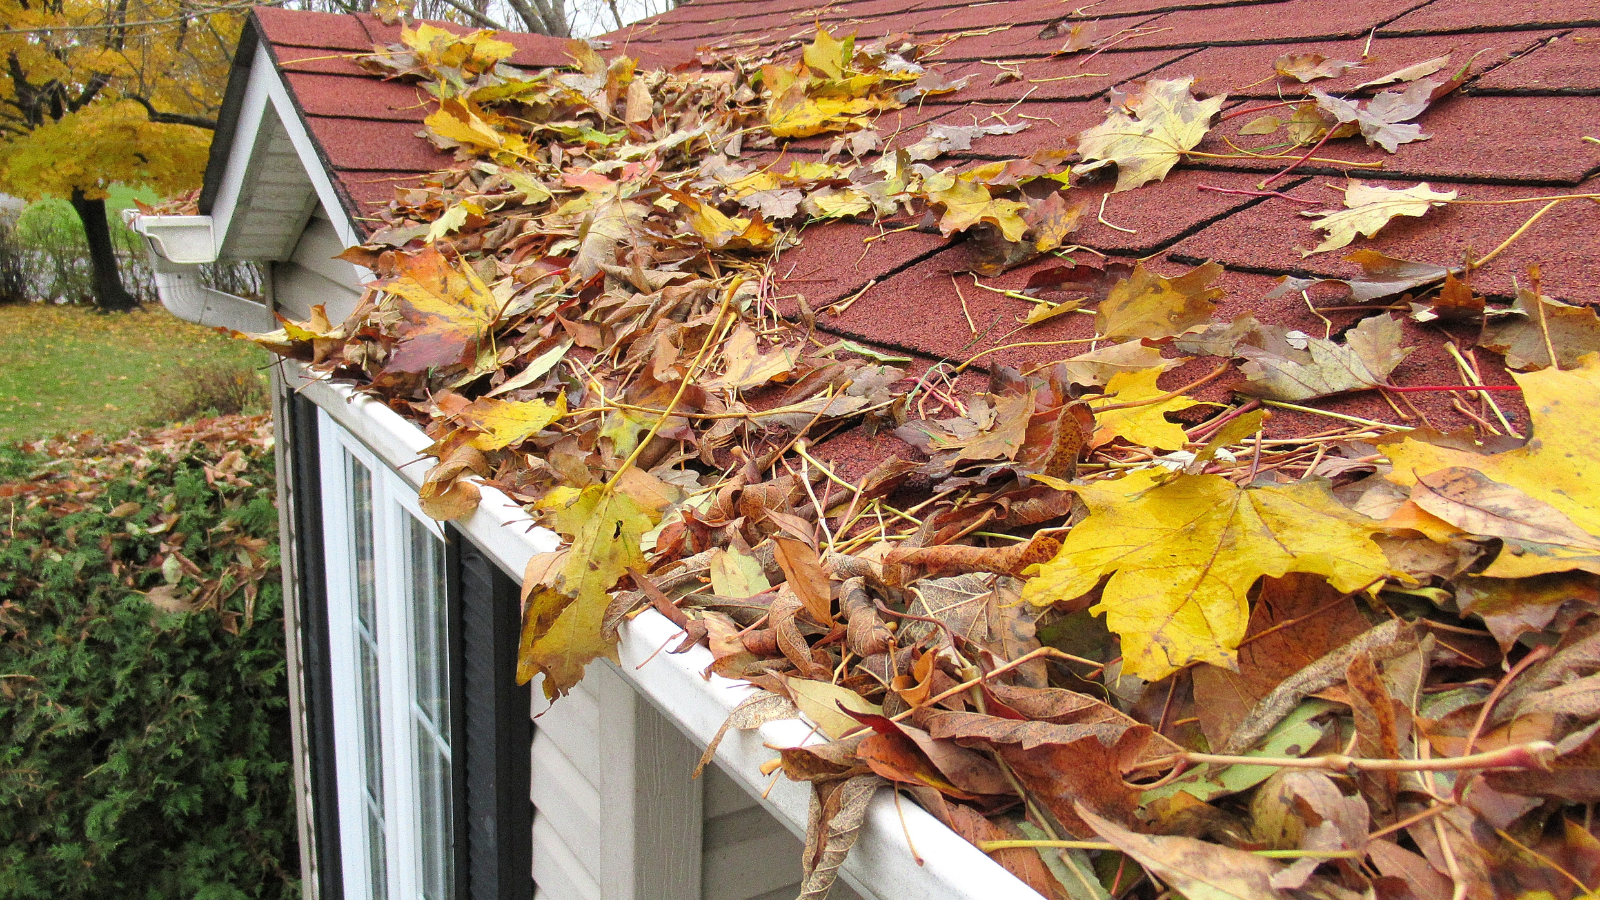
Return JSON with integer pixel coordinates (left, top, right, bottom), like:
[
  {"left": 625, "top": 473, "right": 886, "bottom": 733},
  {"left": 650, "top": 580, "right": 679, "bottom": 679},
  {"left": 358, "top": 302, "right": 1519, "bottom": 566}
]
[{"left": 0, "top": 304, "right": 267, "bottom": 442}]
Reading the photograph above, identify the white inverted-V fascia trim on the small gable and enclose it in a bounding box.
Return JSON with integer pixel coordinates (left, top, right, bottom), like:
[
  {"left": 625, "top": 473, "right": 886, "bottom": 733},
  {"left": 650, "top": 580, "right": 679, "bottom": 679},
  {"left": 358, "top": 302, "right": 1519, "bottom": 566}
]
[{"left": 211, "top": 42, "right": 373, "bottom": 277}]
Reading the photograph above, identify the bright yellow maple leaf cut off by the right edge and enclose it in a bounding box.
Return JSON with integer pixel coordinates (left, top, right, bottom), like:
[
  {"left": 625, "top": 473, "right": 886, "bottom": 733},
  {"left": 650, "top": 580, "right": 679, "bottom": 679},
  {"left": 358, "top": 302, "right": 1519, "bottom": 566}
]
[{"left": 1382, "top": 354, "right": 1600, "bottom": 578}]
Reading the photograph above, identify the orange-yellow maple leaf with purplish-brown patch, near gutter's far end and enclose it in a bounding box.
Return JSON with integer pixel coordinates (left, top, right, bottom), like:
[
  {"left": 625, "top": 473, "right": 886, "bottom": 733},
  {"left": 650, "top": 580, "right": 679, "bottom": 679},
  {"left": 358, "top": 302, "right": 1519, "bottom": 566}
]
[{"left": 384, "top": 247, "right": 501, "bottom": 373}]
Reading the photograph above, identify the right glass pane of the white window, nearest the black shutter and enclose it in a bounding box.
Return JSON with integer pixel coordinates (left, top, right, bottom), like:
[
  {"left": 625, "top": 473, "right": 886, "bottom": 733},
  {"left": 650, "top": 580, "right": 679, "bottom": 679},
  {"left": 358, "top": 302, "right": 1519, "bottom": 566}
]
[{"left": 406, "top": 516, "right": 454, "bottom": 900}]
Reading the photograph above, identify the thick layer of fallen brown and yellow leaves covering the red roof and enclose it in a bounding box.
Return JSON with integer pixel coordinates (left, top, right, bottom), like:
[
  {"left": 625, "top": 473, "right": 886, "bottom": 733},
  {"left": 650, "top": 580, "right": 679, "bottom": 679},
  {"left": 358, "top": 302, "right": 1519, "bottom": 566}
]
[{"left": 259, "top": 19, "right": 1600, "bottom": 900}]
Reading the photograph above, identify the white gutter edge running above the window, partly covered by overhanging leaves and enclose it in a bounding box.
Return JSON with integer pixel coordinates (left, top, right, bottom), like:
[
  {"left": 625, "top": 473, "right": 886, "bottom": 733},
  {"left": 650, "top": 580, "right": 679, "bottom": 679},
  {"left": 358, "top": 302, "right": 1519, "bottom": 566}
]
[{"left": 285, "top": 364, "right": 1040, "bottom": 900}]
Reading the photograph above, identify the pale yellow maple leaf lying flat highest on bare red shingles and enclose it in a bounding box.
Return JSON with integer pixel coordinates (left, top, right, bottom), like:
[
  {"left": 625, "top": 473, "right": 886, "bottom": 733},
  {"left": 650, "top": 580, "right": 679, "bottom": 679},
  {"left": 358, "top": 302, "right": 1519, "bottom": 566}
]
[{"left": 1078, "top": 78, "right": 1227, "bottom": 192}]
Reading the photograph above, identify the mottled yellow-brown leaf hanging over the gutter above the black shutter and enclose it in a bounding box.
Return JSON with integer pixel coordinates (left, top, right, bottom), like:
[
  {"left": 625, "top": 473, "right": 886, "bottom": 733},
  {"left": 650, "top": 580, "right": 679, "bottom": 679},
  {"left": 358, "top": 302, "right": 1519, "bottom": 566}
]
[{"left": 517, "top": 484, "right": 654, "bottom": 700}]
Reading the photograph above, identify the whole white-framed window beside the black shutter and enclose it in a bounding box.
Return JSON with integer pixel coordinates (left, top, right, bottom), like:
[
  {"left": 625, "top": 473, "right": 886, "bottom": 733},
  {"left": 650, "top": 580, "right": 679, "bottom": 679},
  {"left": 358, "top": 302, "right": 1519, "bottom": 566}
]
[{"left": 320, "top": 416, "right": 461, "bottom": 900}]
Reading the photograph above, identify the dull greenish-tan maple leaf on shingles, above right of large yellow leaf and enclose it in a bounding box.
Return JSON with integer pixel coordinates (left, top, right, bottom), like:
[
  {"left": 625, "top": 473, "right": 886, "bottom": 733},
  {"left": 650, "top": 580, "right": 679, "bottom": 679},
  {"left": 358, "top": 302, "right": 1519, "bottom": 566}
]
[{"left": 1234, "top": 315, "right": 1410, "bottom": 402}]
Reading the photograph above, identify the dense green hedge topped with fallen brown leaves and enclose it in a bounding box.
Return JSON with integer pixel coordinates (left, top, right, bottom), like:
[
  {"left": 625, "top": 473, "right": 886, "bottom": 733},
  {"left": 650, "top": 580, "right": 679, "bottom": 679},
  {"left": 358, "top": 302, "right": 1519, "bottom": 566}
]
[{"left": 0, "top": 416, "right": 299, "bottom": 900}]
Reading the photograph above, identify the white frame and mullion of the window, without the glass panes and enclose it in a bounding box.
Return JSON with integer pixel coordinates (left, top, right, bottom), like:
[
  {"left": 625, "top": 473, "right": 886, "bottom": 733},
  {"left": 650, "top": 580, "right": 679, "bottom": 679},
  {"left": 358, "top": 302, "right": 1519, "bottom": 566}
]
[{"left": 317, "top": 410, "right": 462, "bottom": 900}]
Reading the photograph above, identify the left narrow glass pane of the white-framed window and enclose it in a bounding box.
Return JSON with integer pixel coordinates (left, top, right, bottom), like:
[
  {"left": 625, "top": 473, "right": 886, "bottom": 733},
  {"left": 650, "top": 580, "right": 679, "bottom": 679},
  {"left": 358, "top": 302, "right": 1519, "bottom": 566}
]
[{"left": 344, "top": 455, "right": 389, "bottom": 900}]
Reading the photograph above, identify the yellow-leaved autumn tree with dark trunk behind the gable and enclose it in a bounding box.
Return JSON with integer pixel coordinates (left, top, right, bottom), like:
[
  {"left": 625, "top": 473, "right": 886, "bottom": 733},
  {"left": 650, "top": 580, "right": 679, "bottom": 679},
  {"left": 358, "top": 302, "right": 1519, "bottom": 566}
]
[{"left": 0, "top": 0, "right": 248, "bottom": 309}]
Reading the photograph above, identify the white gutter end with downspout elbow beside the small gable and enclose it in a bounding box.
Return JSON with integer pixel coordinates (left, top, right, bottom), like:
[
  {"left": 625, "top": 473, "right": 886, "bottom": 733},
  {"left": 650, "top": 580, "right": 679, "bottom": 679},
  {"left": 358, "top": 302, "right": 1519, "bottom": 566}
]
[{"left": 122, "top": 210, "right": 277, "bottom": 331}]
